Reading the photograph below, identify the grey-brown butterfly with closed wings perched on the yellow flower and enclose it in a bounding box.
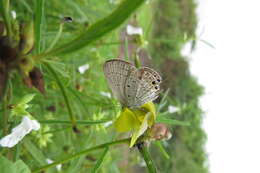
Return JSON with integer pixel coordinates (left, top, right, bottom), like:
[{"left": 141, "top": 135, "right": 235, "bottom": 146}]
[{"left": 104, "top": 59, "right": 162, "bottom": 109}]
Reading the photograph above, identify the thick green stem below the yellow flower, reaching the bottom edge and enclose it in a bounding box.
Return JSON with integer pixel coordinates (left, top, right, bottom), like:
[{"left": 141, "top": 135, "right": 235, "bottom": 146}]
[{"left": 137, "top": 144, "right": 157, "bottom": 173}]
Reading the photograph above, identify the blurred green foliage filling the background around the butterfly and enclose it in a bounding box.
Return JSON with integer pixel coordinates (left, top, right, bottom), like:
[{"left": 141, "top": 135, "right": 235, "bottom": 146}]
[{"left": 0, "top": 0, "right": 207, "bottom": 173}]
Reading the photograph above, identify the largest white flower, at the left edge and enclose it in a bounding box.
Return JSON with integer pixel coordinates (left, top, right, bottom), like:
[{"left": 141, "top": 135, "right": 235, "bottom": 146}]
[{"left": 0, "top": 116, "right": 40, "bottom": 148}]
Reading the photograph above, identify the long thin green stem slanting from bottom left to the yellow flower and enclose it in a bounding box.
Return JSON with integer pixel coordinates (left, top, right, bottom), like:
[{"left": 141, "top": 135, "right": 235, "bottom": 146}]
[{"left": 32, "top": 138, "right": 130, "bottom": 173}]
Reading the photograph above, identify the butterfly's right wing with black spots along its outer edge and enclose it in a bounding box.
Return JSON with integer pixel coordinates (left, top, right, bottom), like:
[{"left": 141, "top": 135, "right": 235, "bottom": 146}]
[{"left": 125, "top": 67, "right": 162, "bottom": 108}]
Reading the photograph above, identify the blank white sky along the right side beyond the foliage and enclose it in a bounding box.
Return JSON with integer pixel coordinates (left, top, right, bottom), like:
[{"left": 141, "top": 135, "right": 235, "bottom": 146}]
[{"left": 187, "top": 0, "right": 260, "bottom": 173}]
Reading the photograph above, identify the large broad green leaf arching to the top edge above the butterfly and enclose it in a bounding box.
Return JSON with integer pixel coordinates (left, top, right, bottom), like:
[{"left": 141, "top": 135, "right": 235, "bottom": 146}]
[{"left": 42, "top": 0, "right": 145, "bottom": 56}]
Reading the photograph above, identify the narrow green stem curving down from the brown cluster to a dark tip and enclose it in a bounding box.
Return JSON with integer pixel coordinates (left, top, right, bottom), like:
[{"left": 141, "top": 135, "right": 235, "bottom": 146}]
[{"left": 44, "top": 63, "right": 76, "bottom": 127}]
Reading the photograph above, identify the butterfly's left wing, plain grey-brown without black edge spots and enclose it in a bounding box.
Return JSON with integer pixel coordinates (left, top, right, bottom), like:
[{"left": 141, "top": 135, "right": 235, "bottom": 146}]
[{"left": 104, "top": 59, "right": 136, "bottom": 106}]
